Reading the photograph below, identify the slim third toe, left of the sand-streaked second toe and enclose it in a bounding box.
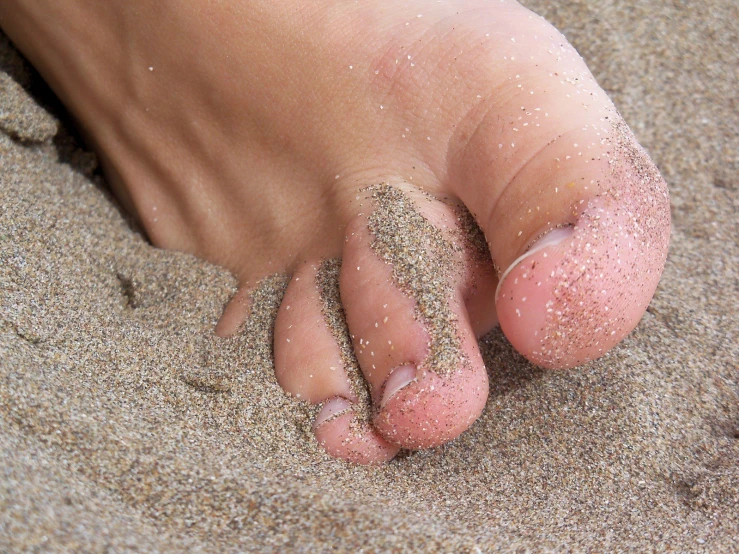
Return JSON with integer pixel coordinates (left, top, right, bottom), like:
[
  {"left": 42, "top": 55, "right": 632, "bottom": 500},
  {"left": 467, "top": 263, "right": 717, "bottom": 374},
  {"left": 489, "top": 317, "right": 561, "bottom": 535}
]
[{"left": 274, "top": 260, "right": 398, "bottom": 464}]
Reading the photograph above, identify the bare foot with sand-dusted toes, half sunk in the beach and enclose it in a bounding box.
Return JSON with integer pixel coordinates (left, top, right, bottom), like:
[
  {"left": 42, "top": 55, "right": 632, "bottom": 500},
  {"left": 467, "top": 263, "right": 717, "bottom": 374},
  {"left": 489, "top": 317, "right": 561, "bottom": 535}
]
[{"left": 0, "top": 0, "right": 670, "bottom": 463}]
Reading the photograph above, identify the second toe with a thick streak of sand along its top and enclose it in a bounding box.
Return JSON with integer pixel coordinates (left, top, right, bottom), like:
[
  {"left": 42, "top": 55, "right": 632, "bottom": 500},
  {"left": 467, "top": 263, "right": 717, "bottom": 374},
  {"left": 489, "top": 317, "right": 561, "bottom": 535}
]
[{"left": 341, "top": 185, "right": 492, "bottom": 448}]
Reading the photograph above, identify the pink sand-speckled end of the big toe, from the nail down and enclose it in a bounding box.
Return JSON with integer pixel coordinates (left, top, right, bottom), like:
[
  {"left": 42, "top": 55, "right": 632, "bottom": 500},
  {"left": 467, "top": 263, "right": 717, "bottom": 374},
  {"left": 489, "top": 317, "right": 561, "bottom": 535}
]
[{"left": 496, "top": 153, "right": 670, "bottom": 368}]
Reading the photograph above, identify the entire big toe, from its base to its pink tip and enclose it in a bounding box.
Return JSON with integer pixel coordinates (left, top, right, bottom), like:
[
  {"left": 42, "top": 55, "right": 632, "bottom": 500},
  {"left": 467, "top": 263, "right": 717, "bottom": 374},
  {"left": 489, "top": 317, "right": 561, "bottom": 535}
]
[{"left": 442, "top": 11, "right": 670, "bottom": 368}]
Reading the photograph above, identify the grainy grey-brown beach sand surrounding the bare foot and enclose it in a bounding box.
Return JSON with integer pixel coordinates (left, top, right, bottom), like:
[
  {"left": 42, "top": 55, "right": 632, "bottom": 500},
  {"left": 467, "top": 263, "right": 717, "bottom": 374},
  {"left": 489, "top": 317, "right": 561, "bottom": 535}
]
[{"left": 0, "top": 0, "right": 739, "bottom": 552}]
